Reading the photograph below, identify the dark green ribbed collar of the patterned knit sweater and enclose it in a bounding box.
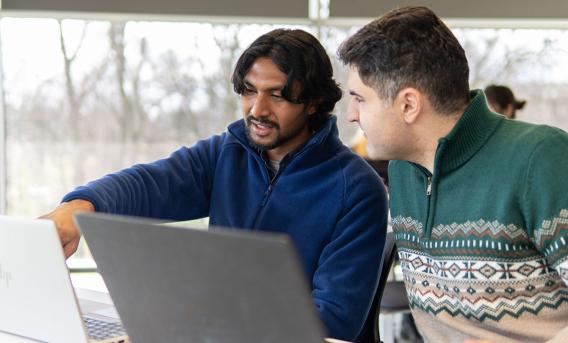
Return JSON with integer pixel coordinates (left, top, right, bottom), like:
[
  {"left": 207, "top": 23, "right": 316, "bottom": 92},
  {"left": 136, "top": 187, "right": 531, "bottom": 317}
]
[{"left": 434, "top": 90, "right": 504, "bottom": 174}]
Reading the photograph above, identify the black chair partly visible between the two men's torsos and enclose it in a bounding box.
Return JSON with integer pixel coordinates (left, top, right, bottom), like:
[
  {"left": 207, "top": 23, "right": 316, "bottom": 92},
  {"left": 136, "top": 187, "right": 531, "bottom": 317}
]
[{"left": 355, "top": 232, "right": 408, "bottom": 343}]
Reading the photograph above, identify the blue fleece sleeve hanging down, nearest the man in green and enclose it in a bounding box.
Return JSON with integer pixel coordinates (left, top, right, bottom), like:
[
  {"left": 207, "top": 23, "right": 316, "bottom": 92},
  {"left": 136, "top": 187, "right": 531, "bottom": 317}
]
[{"left": 312, "top": 161, "right": 388, "bottom": 341}]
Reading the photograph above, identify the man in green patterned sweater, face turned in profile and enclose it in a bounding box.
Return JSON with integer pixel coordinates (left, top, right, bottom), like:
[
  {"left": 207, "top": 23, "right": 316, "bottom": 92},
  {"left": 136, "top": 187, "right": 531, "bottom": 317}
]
[{"left": 339, "top": 7, "right": 568, "bottom": 342}]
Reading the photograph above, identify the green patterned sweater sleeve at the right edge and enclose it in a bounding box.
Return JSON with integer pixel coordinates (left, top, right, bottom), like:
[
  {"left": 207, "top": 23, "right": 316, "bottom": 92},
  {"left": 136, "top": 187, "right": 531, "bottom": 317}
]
[{"left": 524, "top": 128, "right": 568, "bottom": 286}]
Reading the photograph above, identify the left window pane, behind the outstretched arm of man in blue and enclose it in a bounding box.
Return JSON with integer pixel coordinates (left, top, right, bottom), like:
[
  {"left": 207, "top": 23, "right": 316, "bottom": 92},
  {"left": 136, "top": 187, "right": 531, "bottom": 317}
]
[{"left": 1, "top": 18, "right": 311, "bottom": 264}]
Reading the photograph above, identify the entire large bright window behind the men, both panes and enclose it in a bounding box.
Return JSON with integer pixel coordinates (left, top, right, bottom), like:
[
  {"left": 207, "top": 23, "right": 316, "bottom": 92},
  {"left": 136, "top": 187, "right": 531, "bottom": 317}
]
[{"left": 0, "top": 18, "right": 568, "bottom": 266}]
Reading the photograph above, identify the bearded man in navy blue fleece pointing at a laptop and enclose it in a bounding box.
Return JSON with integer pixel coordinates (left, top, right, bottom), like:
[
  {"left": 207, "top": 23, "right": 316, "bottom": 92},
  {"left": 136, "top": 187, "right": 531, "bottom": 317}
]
[{"left": 44, "top": 29, "right": 387, "bottom": 340}]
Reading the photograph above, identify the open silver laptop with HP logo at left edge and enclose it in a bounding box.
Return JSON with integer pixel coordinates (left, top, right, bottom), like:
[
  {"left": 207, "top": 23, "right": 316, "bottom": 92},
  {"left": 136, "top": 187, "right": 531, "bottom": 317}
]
[{"left": 0, "top": 216, "right": 128, "bottom": 343}]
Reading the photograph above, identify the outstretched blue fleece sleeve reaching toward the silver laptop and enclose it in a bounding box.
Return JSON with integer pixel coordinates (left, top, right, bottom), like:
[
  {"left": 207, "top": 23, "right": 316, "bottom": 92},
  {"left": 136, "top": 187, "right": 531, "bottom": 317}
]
[{"left": 62, "top": 135, "right": 225, "bottom": 221}]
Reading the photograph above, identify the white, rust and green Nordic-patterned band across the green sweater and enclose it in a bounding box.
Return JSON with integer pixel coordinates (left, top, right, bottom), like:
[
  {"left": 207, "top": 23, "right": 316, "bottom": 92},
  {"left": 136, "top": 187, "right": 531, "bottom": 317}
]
[{"left": 393, "top": 214, "right": 568, "bottom": 322}]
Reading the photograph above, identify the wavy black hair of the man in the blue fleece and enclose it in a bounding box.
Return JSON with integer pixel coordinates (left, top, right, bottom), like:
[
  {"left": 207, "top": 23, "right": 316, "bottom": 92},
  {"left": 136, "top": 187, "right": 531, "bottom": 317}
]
[{"left": 232, "top": 29, "right": 341, "bottom": 130}]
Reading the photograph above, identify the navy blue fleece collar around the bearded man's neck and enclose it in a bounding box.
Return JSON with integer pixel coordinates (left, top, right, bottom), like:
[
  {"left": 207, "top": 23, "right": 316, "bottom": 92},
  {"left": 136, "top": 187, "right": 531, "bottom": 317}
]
[{"left": 227, "top": 115, "right": 341, "bottom": 157}]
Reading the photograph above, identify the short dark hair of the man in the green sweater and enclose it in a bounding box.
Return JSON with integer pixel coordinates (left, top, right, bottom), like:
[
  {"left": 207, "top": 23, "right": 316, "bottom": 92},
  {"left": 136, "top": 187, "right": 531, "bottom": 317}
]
[{"left": 338, "top": 6, "right": 469, "bottom": 114}]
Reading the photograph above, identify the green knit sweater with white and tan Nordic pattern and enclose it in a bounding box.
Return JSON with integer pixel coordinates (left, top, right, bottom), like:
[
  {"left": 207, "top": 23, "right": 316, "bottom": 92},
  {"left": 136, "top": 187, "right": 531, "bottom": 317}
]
[{"left": 389, "top": 91, "right": 568, "bottom": 343}]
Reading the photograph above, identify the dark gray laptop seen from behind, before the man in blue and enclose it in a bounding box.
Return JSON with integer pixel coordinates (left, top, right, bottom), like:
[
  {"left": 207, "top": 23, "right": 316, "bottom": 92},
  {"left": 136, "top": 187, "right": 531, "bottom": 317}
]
[{"left": 75, "top": 213, "right": 324, "bottom": 343}]
